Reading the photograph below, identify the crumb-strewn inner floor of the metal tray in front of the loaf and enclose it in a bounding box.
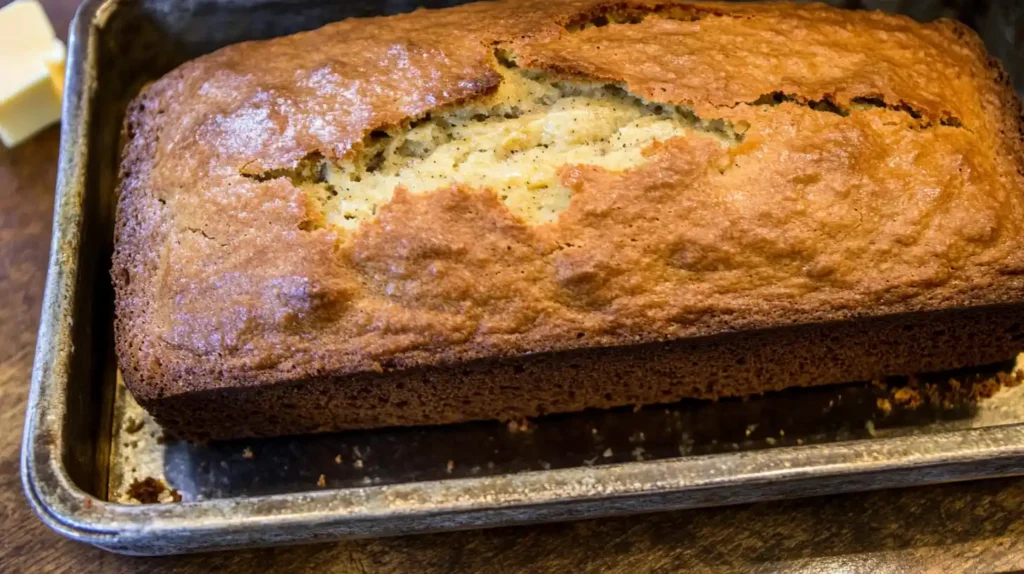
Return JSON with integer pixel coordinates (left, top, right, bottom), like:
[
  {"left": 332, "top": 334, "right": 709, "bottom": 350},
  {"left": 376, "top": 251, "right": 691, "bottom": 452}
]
[{"left": 109, "top": 354, "right": 1024, "bottom": 503}]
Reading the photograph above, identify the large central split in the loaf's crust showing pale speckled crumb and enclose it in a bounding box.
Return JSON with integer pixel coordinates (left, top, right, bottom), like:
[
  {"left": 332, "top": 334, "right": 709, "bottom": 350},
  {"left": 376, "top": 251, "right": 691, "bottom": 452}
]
[{"left": 240, "top": 50, "right": 750, "bottom": 230}]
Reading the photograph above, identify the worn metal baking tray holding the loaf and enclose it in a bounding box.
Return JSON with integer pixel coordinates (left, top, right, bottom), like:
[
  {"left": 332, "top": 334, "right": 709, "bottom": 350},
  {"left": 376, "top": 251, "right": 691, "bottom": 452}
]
[{"left": 22, "top": 0, "right": 1024, "bottom": 555}]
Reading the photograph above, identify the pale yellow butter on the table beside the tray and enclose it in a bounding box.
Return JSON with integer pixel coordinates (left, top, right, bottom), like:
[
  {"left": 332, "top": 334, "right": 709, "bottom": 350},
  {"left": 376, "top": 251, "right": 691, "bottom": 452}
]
[{"left": 0, "top": 0, "right": 66, "bottom": 147}]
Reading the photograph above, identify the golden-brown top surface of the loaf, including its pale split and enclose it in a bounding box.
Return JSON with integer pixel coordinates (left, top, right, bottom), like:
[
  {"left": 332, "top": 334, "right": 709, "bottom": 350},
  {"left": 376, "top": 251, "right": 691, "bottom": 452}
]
[{"left": 113, "top": 0, "right": 1024, "bottom": 396}]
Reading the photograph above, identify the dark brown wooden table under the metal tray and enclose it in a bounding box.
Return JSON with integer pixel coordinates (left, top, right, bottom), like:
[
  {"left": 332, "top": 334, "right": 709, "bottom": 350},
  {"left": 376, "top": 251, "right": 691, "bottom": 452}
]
[{"left": 6, "top": 0, "right": 1024, "bottom": 573}]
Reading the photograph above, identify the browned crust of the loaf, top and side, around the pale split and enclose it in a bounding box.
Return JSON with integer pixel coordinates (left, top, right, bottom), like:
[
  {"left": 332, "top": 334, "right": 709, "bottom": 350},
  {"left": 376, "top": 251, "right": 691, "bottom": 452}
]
[{"left": 112, "top": 0, "right": 1024, "bottom": 438}]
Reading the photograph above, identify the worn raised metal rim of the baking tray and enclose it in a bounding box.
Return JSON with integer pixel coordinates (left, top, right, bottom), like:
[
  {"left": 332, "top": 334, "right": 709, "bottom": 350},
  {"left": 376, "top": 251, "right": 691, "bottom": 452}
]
[{"left": 22, "top": 0, "right": 1024, "bottom": 555}]
